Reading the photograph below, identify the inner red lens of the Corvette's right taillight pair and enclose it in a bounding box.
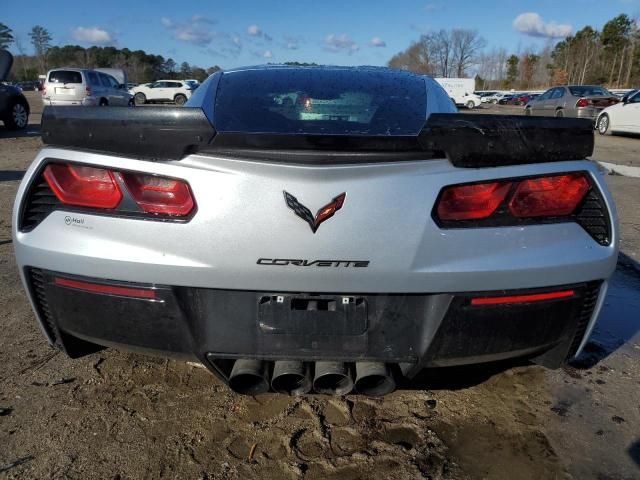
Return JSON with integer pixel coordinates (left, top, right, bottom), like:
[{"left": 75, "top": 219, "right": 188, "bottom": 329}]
[{"left": 438, "top": 182, "right": 511, "bottom": 220}]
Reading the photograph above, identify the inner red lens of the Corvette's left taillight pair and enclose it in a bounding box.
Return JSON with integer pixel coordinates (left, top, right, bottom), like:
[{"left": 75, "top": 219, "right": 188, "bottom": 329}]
[{"left": 122, "top": 173, "right": 194, "bottom": 216}]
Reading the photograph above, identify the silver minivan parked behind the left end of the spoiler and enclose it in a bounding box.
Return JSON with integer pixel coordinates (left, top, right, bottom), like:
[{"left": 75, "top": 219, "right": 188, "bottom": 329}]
[{"left": 42, "top": 68, "right": 134, "bottom": 106}]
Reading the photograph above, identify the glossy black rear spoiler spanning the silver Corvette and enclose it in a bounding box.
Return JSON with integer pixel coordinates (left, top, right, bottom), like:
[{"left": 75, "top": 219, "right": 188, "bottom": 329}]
[{"left": 42, "top": 107, "right": 593, "bottom": 168}]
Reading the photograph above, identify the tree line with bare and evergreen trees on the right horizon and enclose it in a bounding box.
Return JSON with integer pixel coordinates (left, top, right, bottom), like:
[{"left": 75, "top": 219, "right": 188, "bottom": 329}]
[{"left": 388, "top": 14, "right": 640, "bottom": 90}]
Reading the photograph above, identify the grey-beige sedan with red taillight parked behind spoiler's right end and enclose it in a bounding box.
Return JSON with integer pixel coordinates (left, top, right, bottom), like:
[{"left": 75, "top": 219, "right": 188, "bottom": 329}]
[{"left": 525, "top": 85, "right": 619, "bottom": 120}]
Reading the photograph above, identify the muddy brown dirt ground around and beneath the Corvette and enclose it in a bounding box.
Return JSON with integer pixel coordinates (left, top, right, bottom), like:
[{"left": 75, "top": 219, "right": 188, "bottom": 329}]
[{"left": 0, "top": 94, "right": 640, "bottom": 480}]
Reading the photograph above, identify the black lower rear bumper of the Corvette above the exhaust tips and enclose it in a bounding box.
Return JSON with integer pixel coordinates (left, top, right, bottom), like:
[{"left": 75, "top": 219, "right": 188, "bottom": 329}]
[{"left": 31, "top": 269, "right": 605, "bottom": 378}]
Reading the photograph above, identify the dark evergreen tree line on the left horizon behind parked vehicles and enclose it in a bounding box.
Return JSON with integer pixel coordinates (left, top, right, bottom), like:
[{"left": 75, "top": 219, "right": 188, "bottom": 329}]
[{"left": 0, "top": 23, "right": 220, "bottom": 83}]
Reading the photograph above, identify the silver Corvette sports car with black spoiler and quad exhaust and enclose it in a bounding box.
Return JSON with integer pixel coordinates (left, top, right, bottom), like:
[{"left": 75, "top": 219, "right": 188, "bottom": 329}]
[{"left": 13, "top": 66, "right": 618, "bottom": 395}]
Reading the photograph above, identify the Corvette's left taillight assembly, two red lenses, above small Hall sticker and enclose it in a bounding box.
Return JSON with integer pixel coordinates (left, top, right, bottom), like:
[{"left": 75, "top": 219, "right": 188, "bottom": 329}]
[{"left": 21, "top": 162, "right": 196, "bottom": 231}]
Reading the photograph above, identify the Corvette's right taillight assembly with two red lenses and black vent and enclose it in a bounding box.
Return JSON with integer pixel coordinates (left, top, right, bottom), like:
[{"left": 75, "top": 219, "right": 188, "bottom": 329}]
[{"left": 432, "top": 172, "right": 611, "bottom": 245}]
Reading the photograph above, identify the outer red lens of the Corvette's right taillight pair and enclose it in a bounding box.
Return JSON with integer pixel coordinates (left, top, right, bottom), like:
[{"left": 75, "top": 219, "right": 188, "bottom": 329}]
[{"left": 509, "top": 173, "right": 589, "bottom": 218}]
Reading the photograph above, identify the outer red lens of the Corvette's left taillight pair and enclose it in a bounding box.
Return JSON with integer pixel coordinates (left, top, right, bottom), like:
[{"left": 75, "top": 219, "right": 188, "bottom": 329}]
[{"left": 44, "top": 163, "right": 122, "bottom": 208}]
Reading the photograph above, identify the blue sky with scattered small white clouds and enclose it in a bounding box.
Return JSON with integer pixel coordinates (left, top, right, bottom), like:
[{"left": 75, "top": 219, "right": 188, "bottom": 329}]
[{"left": 0, "top": 0, "right": 640, "bottom": 68}]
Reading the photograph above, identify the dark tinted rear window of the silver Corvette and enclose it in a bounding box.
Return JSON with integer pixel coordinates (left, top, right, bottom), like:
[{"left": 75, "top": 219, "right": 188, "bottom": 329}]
[{"left": 214, "top": 68, "right": 426, "bottom": 136}]
